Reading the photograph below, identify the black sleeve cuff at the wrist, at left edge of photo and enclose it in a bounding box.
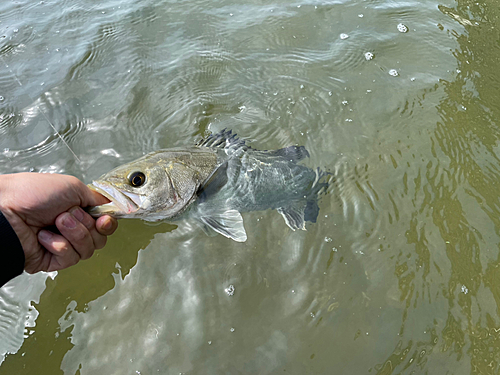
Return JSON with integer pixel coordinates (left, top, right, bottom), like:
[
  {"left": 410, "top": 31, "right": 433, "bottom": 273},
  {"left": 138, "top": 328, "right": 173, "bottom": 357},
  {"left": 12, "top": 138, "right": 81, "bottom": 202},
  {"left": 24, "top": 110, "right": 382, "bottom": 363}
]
[{"left": 0, "top": 212, "right": 24, "bottom": 288}]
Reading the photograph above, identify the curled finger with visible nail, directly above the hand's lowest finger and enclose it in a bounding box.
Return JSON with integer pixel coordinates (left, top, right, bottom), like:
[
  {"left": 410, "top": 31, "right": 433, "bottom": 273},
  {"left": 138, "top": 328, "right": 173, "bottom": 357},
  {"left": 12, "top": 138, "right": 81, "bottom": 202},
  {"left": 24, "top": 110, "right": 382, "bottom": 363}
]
[{"left": 56, "top": 212, "right": 95, "bottom": 259}]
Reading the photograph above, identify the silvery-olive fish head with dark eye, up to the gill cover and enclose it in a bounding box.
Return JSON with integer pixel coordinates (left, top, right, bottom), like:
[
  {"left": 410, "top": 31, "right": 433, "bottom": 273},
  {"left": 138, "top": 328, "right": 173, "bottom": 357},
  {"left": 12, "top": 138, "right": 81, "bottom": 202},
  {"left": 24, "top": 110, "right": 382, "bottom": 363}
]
[{"left": 88, "top": 155, "right": 198, "bottom": 221}]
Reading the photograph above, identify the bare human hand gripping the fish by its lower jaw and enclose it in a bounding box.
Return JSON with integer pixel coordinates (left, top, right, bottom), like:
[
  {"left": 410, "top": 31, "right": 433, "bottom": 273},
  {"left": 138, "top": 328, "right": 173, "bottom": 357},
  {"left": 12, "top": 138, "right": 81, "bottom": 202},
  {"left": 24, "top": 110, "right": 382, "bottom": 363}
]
[{"left": 0, "top": 173, "right": 118, "bottom": 273}]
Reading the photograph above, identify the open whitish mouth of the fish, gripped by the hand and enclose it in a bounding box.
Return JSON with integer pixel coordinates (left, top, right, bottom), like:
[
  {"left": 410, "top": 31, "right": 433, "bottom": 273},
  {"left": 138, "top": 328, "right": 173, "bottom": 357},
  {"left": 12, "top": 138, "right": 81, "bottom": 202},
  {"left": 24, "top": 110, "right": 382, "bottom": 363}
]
[{"left": 87, "top": 181, "right": 142, "bottom": 218}]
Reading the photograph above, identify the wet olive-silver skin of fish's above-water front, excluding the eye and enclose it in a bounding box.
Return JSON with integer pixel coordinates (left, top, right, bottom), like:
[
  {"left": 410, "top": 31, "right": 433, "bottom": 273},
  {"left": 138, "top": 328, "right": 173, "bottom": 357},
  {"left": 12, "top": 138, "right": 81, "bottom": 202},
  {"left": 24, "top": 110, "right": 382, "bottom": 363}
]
[{"left": 89, "top": 147, "right": 220, "bottom": 221}]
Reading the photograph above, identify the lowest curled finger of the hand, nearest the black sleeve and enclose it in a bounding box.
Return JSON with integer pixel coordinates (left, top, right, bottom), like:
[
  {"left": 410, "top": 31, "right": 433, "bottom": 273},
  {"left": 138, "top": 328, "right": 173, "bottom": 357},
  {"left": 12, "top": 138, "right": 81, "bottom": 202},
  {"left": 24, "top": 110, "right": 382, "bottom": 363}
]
[{"left": 38, "top": 230, "right": 80, "bottom": 272}]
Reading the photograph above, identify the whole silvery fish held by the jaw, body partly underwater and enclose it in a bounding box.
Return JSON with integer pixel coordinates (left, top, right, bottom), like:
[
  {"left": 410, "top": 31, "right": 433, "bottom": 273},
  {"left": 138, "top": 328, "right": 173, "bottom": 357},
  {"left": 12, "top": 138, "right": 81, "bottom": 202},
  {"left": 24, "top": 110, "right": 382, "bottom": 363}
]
[{"left": 88, "top": 129, "right": 329, "bottom": 242}]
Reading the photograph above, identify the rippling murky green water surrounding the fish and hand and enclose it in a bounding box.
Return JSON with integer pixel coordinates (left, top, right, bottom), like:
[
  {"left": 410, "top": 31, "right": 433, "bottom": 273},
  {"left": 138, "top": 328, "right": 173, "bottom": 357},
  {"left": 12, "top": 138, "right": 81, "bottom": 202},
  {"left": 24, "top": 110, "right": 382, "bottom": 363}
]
[{"left": 0, "top": 0, "right": 500, "bottom": 375}]
